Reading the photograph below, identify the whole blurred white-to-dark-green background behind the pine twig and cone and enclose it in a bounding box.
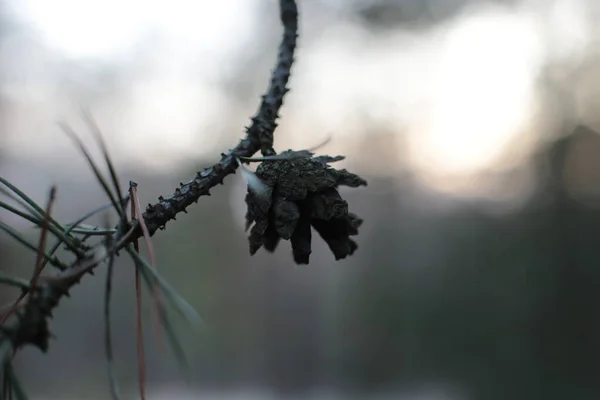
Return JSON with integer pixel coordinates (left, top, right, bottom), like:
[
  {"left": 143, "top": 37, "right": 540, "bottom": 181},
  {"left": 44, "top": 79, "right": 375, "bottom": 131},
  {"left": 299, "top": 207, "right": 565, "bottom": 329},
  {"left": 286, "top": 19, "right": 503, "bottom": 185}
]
[{"left": 0, "top": 0, "right": 600, "bottom": 400}]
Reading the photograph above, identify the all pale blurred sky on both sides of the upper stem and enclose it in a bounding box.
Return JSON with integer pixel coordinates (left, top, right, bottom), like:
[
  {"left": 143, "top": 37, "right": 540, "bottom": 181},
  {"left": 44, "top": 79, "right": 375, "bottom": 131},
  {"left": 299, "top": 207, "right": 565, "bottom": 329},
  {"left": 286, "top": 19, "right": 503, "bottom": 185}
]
[{"left": 5, "top": 0, "right": 591, "bottom": 195}]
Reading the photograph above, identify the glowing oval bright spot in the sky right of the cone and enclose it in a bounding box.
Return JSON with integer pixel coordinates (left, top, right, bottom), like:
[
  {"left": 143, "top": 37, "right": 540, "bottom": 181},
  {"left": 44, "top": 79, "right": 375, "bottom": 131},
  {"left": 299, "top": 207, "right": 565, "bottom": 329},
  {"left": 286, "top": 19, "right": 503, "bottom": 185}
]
[{"left": 414, "top": 7, "right": 543, "bottom": 173}]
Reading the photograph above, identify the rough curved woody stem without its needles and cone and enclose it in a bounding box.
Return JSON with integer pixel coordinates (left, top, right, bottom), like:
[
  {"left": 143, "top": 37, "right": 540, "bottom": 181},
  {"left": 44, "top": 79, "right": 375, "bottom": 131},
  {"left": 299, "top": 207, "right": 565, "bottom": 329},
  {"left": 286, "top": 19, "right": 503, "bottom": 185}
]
[{"left": 0, "top": 0, "right": 298, "bottom": 358}]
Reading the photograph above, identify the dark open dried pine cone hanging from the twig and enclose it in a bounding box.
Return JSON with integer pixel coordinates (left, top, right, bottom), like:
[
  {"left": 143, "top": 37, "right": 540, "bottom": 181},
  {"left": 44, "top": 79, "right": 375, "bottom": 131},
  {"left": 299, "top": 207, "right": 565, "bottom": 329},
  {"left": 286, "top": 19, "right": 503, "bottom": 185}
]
[{"left": 246, "top": 151, "right": 367, "bottom": 264}]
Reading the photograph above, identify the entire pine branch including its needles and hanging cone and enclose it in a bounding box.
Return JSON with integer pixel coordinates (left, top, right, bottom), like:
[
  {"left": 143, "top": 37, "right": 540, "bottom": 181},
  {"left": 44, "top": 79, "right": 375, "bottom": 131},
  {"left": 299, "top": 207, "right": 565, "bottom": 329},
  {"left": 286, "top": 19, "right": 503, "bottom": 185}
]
[{"left": 0, "top": 0, "right": 367, "bottom": 398}]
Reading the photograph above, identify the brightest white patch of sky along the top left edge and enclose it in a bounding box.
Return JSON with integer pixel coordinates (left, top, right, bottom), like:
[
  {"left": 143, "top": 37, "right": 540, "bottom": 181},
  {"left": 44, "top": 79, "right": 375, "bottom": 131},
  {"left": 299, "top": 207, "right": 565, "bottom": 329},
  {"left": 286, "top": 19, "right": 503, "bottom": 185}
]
[{"left": 10, "top": 0, "right": 258, "bottom": 58}]
